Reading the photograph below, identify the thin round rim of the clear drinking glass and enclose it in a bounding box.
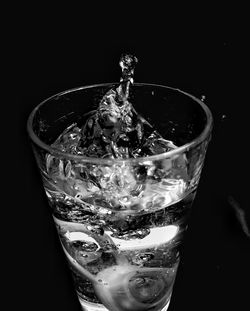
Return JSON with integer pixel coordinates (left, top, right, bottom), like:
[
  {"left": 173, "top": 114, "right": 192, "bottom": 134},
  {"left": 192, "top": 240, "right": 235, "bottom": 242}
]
[{"left": 27, "top": 82, "right": 213, "bottom": 165}]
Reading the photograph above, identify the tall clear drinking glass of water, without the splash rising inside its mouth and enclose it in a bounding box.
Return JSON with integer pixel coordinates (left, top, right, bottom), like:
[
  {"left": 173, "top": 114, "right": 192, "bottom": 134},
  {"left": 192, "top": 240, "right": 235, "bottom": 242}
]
[{"left": 27, "top": 83, "right": 212, "bottom": 311}]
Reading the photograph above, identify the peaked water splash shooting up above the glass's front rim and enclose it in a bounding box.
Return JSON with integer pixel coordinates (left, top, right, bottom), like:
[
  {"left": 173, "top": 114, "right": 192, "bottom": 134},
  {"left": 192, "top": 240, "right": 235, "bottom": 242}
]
[{"left": 50, "top": 54, "right": 176, "bottom": 159}]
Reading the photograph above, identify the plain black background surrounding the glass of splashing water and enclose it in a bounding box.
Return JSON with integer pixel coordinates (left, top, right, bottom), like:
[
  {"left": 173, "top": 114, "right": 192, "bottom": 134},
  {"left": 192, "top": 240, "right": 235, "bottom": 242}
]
[{"left": 2, "top": 4, "right": 250, "bottom": 311}]
